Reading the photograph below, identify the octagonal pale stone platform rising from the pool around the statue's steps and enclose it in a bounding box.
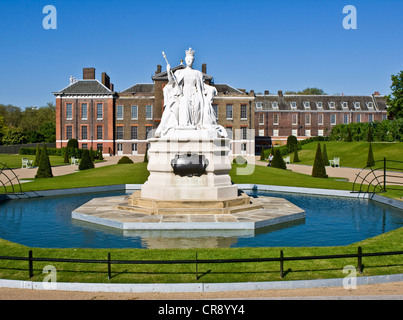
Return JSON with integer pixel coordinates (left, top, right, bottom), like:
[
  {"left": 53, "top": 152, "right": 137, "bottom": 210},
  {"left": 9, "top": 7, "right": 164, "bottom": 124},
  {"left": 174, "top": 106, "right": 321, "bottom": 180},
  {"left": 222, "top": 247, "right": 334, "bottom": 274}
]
[{"left": 72, "top": 192, "right": 305, "bottom": 230}]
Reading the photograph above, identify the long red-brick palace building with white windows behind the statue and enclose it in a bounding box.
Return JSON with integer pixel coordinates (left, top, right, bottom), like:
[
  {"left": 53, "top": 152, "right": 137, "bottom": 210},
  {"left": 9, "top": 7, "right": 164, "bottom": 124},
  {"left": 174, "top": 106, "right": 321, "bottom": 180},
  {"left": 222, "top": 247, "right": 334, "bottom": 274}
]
[{"left": 53, "top": 63, "right": 387, "bottom": 156}]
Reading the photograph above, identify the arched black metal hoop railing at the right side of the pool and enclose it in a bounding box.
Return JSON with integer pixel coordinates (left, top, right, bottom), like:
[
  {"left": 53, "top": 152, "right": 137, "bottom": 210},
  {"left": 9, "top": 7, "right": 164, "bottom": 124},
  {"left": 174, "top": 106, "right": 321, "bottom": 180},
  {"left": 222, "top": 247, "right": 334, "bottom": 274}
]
[{"left": 351, "top": 158, "right": 403, "bottom": 194}]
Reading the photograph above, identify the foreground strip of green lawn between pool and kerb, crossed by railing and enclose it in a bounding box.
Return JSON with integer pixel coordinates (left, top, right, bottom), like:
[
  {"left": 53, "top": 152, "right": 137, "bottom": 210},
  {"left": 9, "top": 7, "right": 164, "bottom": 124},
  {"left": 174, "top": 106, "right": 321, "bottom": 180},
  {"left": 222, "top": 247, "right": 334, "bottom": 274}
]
[{"left": 0, "top": 228, "right": 403, "bottom": 283}]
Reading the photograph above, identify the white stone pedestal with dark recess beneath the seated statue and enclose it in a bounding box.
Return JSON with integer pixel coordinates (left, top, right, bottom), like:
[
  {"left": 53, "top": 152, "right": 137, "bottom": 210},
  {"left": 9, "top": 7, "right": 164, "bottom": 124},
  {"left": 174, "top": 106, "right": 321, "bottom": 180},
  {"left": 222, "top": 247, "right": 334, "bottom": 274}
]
[{"left": 141, "top": 128, "right": 238, "bottom": 200}]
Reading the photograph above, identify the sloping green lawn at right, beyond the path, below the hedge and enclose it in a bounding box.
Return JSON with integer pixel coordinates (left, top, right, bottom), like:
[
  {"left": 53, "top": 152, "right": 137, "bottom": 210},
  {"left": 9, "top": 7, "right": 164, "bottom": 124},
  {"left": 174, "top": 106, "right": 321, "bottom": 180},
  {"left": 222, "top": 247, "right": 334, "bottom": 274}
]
[{"left": 290, "top": 141, "right": 403, "bottom": 169}]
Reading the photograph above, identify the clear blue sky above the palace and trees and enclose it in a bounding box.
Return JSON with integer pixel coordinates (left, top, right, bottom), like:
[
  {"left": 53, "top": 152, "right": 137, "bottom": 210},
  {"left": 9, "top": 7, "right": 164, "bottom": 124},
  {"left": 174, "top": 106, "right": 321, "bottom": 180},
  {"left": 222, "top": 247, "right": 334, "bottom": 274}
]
[{"left": 0, "top": 0, "right": 403, "bottom": 108}]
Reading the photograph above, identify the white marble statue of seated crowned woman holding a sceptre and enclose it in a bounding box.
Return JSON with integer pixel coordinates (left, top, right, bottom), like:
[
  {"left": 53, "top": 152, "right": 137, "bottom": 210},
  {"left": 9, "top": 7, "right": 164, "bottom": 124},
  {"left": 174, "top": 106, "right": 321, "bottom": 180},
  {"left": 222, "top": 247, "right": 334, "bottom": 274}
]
[{"left": 155, "top": 48, "right": 227, "bottom": 137}]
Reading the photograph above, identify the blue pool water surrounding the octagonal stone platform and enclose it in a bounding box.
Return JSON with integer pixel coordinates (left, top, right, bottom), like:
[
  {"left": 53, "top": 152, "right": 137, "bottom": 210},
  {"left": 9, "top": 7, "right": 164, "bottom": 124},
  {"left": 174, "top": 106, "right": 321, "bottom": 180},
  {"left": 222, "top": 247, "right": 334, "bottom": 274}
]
[{"left": 0, "top": 191, "right": 403, "bottom": 248}]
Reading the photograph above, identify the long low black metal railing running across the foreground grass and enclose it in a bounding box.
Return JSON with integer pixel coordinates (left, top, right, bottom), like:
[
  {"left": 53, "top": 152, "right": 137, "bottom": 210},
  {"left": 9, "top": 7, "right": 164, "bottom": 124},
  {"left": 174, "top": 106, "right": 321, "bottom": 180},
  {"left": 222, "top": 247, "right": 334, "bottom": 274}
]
[{"left": 0, "top": 247, "right": 403, "bottom": 280}]
